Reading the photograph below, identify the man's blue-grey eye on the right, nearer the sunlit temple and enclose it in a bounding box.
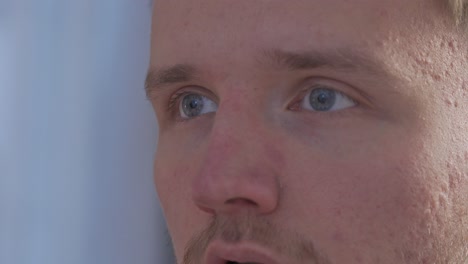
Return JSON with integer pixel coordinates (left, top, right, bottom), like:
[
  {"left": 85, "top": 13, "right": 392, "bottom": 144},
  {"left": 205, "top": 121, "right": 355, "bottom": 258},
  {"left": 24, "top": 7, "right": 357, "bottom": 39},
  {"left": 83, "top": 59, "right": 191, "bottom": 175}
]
[{"left": 302, "top": 88, "right": 356, "bottom": 112}]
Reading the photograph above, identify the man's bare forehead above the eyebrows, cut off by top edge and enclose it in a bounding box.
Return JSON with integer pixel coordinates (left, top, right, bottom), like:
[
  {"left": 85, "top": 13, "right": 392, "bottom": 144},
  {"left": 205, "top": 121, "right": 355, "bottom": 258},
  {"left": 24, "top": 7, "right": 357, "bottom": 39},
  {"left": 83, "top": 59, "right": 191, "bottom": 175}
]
[{"left": 152, "top": 0, "right": 439, "bottom": 67}]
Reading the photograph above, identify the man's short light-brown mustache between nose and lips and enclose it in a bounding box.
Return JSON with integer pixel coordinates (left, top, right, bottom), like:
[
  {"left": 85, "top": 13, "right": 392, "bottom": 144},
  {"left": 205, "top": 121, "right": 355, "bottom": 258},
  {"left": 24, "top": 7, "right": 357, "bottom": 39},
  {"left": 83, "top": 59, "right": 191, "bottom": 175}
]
[{"left": 182, "top": 214, "right": 330, "bottom": 264}]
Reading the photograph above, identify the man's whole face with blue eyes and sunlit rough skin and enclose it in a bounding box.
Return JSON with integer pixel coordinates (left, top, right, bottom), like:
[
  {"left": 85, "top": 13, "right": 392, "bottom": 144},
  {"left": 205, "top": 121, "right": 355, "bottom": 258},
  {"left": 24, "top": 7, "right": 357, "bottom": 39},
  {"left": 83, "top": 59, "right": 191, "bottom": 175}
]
[{"left": 147, "top": 0, "right": 468, "bottom": 264}]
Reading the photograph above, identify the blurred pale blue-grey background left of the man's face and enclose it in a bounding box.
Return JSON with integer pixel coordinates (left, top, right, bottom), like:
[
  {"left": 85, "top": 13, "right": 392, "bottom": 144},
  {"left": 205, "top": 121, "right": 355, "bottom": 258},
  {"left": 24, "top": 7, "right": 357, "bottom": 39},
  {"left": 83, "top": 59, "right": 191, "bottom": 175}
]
[{"left": 0, "top": 0, "right": 173, "bottom": 264}]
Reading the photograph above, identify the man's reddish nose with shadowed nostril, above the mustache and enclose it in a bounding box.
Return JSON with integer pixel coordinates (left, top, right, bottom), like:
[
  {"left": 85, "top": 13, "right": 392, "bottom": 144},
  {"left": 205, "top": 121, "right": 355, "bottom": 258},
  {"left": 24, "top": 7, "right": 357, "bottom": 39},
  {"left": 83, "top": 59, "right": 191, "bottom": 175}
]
[{"left": 192, "top": 119, "right": 281, "bottom": 215}]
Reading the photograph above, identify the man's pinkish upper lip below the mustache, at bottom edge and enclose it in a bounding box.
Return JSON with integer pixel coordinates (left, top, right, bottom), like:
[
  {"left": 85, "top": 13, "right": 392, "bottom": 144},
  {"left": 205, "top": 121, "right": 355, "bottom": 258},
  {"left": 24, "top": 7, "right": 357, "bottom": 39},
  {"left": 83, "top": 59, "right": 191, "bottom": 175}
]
[{"left": 203, "top": 241, "right": 284, "bottom": 264}]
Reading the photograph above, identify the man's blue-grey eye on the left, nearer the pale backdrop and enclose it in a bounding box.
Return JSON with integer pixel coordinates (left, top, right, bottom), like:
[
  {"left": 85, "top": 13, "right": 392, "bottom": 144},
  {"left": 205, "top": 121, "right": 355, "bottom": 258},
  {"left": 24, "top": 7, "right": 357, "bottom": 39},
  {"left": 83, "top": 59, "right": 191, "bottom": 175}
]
[{"left": 179, "top": 93, "right": 218, "bottom": 119}]
